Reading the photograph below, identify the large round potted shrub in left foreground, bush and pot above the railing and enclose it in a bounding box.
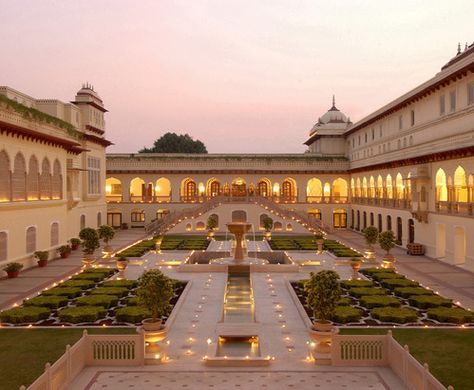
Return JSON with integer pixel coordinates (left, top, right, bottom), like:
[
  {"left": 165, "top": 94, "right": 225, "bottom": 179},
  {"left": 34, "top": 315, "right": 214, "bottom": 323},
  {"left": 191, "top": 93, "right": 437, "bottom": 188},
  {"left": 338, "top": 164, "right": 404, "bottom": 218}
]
[{"left": 137, "top": 269, "right": 174, "bottom": 331}]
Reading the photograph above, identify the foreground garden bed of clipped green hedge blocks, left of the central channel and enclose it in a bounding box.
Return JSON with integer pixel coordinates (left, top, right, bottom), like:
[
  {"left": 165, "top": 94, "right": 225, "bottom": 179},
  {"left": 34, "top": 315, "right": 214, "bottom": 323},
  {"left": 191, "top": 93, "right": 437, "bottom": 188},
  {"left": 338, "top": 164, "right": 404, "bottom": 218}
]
[{"left": 0, "top": 268, "right": 186, "bottom": 326}]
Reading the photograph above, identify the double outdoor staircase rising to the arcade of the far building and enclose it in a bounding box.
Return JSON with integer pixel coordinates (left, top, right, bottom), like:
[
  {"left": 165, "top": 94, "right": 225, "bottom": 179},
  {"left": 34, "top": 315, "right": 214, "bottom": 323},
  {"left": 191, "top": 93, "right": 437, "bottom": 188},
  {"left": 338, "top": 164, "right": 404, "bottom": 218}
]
[{"left": 145, "top": 195, "right": 332, "bottom": 234}]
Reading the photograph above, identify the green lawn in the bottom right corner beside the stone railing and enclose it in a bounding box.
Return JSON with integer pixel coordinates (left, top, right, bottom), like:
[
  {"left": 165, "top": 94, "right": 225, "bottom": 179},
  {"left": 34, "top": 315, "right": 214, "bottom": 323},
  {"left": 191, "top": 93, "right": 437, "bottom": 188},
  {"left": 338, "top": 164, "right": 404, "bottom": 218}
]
[{"left": 340, "top": 328, "right": 474, "bottom": 390}]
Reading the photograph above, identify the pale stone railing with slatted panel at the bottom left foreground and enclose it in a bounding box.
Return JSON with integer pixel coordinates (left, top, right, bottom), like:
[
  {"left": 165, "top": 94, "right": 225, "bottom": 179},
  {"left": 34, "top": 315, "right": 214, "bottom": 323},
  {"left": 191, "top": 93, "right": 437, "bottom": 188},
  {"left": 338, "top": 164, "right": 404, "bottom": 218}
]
[{"left": 24, "top": 330, "right": 145, "bottom": 390}]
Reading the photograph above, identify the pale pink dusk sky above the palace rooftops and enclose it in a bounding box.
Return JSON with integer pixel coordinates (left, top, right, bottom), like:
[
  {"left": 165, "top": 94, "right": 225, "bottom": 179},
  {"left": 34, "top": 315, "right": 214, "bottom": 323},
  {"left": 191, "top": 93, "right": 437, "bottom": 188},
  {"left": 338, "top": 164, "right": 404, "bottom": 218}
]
[{"left": 0, "top": 0, "right": 474, "bottom": 153}]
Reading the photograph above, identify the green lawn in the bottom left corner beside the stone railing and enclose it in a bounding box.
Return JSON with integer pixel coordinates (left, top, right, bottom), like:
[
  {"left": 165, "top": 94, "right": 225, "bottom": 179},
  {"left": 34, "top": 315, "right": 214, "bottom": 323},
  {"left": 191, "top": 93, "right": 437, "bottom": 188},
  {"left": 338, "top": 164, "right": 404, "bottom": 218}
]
[{"left": 0, "top": 328, "right": 136, "bottom": 390}]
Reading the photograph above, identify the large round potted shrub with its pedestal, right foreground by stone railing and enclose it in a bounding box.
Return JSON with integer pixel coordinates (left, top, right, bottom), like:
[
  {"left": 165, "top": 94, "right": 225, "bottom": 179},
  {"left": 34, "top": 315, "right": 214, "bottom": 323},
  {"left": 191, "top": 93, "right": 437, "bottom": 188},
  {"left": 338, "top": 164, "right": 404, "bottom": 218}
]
[{"left": 304, "top": 270, "right": 342, "bottom": 354}]
